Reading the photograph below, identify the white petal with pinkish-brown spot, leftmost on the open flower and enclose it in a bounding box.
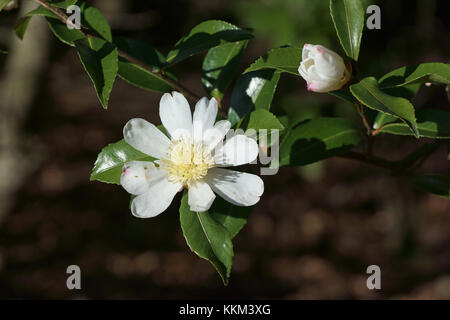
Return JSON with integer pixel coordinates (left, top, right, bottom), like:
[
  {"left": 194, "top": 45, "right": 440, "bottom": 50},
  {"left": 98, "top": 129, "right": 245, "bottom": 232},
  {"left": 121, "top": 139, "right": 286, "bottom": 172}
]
[{"left": 120, "top": 161, "right": 157, "bottom": 195}]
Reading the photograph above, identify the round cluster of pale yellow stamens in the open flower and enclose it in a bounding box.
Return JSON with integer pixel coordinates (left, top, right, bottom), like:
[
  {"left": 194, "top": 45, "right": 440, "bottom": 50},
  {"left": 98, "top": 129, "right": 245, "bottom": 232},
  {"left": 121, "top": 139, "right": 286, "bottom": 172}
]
[{"left": 161, "top": 138, "right": 214, "bottom": 186}]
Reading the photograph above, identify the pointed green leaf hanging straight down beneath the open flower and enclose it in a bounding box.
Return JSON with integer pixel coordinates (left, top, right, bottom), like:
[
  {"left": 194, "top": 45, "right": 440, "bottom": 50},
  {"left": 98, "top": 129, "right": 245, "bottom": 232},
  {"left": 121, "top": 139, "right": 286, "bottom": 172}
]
[{"left": 180, "top": 193, "right": 233, "bottom": 285}]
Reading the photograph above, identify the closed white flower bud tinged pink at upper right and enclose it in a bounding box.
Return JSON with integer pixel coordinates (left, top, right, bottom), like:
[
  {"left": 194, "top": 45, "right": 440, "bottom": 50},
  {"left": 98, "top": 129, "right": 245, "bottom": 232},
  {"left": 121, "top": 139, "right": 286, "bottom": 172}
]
[{"left": 298, "top": 44, "right": 351, "bottom": 92}]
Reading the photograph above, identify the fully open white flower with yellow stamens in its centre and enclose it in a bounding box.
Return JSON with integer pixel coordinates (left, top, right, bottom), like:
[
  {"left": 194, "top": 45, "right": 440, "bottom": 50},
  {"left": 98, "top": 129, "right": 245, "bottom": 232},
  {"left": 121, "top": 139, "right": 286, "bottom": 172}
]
[{"left": 120, "top": 92, "right": 264, "bottom": 218}]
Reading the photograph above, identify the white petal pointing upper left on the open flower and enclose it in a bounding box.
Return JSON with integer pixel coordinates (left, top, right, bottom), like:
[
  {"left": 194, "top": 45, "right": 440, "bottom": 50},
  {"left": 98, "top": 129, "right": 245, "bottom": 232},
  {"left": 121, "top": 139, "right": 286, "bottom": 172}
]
[{"left": 123, "top": 118, "right": 171, "bottom": 159}]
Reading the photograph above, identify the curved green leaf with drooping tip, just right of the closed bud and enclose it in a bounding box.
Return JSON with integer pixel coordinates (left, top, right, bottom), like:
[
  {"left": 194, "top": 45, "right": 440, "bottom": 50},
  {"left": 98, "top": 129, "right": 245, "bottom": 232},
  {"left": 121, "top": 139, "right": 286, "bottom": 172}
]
[{"left": 350, "top": 77, "right": 419, "bottom": 137}]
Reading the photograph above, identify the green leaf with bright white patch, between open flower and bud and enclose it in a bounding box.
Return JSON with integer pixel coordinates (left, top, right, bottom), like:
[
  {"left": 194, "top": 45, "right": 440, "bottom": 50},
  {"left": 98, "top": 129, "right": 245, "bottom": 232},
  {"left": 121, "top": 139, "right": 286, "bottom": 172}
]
[{"left": 228, "top": 70, "right": 280, "bottom": 125}]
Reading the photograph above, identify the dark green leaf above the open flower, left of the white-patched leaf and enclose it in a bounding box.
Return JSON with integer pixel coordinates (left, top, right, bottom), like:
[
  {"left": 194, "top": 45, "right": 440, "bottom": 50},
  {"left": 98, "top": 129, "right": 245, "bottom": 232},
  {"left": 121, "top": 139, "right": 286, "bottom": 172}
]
[{"left": 202, "top": 41, "right": 247, "bottom": 100}]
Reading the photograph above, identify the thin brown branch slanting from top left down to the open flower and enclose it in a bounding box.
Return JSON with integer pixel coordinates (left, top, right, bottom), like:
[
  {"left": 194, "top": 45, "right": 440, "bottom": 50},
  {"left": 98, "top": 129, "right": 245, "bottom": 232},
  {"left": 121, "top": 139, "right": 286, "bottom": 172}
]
[{"left": 33, "top": 0, "right": 200, "bottom": 102}]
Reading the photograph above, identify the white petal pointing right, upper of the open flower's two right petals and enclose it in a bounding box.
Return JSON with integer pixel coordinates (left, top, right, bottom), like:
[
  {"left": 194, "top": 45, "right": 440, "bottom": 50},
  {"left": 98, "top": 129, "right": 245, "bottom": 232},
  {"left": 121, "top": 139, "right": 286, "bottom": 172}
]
[{"left": 214, "top": 134, "right": 259, "bottom": 166}]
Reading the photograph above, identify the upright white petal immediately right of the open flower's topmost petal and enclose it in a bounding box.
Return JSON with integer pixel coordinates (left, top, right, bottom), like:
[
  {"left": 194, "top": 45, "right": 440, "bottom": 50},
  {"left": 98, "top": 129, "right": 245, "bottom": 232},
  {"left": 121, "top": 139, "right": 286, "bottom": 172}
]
[{"left": 193, "top": 98, "right": 218, "bottom": 141}]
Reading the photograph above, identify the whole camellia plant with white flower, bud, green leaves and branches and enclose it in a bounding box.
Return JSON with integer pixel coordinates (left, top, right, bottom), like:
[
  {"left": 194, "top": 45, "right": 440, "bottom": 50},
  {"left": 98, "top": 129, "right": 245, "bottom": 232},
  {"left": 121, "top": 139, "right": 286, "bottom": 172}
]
[{"left": 4, "top": 0, "right": 450, "bottom": 284}]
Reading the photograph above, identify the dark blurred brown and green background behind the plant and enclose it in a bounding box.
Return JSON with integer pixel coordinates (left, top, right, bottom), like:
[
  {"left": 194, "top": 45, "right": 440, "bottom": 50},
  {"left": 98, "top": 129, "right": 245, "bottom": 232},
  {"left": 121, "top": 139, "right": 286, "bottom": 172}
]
[{"left": 0, "top": 0, "right": 450, "bottom": 299}]
